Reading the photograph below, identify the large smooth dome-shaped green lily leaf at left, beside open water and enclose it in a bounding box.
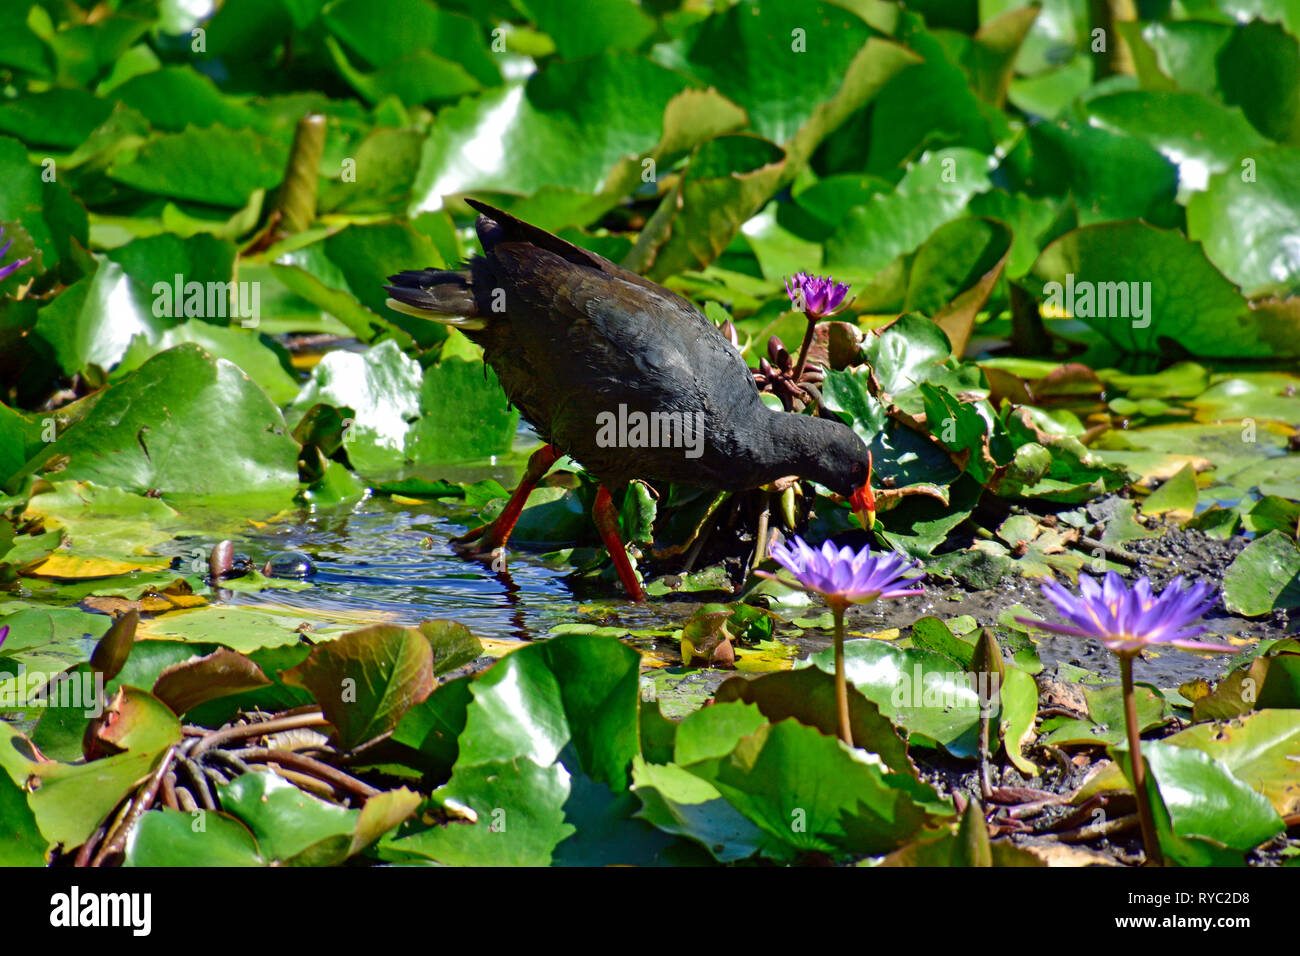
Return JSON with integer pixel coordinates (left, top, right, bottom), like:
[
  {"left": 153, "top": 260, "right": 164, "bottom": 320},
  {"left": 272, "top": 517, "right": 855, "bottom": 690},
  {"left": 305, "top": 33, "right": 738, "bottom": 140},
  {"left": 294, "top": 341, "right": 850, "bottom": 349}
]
[{"left": 20, "top": 345, "right": 298, "bottom": 494}]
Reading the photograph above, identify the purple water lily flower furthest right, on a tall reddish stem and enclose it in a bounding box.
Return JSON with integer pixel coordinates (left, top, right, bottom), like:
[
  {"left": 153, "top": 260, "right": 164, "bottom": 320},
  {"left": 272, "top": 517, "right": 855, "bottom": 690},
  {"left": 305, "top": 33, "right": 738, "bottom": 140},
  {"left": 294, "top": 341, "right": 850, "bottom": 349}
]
[{"left": 1017, "top": 571, "right": 1238, "bottom": 654}]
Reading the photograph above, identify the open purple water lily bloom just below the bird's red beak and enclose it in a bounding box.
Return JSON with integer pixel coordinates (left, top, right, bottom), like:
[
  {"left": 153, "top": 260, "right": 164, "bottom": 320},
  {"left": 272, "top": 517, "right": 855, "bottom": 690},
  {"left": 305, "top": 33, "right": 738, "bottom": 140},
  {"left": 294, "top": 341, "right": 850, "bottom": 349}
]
[{"left": 757, "top": 536, "right": 924, "bottom": 605}]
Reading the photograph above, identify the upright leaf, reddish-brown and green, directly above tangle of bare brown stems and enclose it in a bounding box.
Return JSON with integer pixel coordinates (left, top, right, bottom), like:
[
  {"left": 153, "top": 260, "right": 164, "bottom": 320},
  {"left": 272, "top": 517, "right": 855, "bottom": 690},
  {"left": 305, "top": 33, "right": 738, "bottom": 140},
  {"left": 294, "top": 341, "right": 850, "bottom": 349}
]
[{"left": 280, "top": 624, "right": 436, "bottom": 749}]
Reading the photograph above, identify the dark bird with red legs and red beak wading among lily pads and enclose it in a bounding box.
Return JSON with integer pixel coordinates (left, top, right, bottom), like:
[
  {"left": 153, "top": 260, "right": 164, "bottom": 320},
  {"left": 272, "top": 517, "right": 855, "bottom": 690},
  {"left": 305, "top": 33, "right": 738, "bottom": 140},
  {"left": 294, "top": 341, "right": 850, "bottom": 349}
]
[{"left": 385, "top": 199, "right": 875, "bottom": 601}]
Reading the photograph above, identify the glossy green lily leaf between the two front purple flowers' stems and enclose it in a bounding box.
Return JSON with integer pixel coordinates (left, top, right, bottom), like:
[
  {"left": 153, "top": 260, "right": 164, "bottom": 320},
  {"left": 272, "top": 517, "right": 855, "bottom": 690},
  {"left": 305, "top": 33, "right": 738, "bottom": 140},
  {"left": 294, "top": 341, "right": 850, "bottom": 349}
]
[{"left": 809, "top": 639, "right": 980, "bottom": 757}]
